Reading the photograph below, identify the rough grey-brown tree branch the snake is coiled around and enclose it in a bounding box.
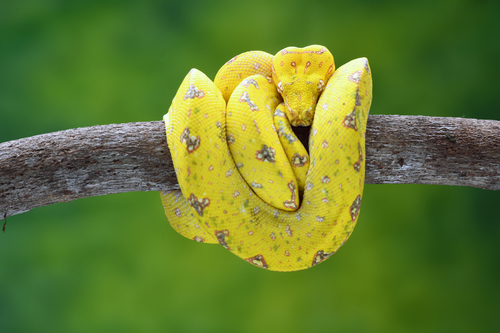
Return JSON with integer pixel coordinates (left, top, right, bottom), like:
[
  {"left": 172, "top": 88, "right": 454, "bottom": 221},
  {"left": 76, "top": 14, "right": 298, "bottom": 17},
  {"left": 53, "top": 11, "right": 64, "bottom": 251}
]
[{"left": 0, "top": 115, "right": 500, "bottom": 217}]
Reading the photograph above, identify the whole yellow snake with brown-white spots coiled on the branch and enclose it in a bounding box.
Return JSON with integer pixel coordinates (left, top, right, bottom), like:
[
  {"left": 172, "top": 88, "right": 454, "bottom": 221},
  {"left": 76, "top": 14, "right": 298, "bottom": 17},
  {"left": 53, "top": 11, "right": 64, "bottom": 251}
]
[{"left": 161, "top": 45, "right": 372, "bottom": 271}]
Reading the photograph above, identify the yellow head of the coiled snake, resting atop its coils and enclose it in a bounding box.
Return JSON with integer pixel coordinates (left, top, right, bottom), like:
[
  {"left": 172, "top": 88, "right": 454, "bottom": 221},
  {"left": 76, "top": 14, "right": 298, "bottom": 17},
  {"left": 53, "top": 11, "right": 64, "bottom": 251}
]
[{"left": 272, "top": 45, "right": 335, "bottom": 126}]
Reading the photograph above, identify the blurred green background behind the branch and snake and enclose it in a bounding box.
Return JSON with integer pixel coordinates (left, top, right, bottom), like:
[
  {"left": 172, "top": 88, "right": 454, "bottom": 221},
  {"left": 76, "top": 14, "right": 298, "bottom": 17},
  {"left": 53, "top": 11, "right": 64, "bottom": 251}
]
[{"left": 0, "top": 0, "right": 500, "bottom": 332}]
